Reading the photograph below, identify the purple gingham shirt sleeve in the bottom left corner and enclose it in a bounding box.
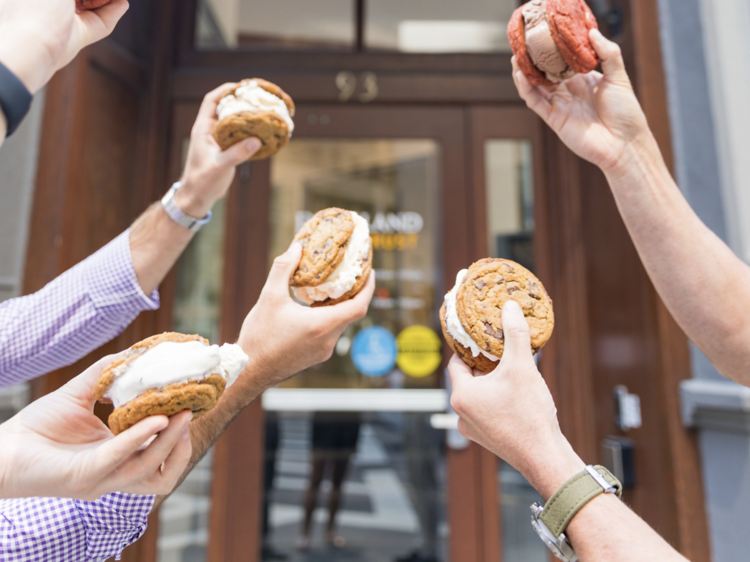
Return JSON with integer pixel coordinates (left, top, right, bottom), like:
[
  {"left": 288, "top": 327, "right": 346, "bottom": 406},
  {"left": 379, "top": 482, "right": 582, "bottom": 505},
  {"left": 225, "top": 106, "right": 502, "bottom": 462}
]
[{"left": 0, "top": 492, "right": 154, "bottom": 562}]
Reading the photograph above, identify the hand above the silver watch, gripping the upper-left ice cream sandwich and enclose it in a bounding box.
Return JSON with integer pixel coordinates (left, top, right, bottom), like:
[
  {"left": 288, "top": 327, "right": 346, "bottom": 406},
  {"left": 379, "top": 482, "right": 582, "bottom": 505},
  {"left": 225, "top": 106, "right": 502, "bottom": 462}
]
[{"left": 175, "top": 84, "right": 261, "bottom": 218}]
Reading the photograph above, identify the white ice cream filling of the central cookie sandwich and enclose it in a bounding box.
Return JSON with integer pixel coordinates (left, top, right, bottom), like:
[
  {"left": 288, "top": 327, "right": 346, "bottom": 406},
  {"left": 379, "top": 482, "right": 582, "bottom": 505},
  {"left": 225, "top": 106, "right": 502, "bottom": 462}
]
[{"left": 294, "top": 211, "right": 370, "bottom": 304}]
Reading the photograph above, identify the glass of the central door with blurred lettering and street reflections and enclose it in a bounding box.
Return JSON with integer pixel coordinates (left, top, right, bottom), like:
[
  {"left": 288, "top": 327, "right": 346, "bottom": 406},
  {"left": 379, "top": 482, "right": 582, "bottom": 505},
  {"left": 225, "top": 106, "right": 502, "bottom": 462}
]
[{"left": 262, "top": 139, "right": 447, "bottom": 562}]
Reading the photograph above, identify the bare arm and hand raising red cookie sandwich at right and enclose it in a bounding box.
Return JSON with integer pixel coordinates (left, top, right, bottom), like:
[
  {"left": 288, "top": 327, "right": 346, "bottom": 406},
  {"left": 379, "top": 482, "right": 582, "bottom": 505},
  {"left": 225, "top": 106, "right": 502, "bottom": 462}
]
[{"left": 514, "top": 31, "right": 750, "bottom": 384}]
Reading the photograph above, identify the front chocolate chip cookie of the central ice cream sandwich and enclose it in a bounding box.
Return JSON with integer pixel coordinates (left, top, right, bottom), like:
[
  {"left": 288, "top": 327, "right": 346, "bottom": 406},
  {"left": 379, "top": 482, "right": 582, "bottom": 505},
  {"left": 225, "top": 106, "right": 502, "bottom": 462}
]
[{"left": 292, "top": 207, "right": 356, "bottom": 287}]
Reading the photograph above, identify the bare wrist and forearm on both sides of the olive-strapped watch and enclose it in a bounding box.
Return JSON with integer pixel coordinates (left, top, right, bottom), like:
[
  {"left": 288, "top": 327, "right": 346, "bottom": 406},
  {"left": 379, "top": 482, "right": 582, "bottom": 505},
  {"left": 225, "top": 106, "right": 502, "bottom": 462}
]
[{"left": 522, "top": 441, "right": 685, "bottom": 562}]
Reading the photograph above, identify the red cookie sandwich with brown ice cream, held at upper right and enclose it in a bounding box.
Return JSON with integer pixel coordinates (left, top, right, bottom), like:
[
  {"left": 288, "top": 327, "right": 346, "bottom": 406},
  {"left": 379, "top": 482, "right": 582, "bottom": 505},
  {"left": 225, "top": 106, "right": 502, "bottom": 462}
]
[{"left": 508, "top": 0, "right": 599, "bottom": 86}]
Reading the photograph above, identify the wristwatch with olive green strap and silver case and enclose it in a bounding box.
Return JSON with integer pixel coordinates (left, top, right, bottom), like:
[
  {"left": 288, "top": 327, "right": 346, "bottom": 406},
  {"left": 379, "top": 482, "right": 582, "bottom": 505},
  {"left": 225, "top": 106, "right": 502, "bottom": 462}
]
[{"left": 531, "top": 465, "right": 622, "bottom": 562}]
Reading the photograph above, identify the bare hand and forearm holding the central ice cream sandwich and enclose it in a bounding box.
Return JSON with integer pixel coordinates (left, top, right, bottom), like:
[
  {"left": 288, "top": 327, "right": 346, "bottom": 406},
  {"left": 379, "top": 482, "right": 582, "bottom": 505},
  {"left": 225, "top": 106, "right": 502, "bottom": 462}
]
[{"left": 156, "top": 244, "right": 375, "bottom": 505}]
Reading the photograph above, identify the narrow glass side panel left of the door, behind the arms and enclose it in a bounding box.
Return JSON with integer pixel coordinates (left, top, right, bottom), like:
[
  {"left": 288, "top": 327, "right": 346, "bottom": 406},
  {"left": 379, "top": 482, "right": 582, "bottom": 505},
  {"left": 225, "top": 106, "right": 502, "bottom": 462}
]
[{"left": 158, "top": 200, "right": 226, "bottom": 562}]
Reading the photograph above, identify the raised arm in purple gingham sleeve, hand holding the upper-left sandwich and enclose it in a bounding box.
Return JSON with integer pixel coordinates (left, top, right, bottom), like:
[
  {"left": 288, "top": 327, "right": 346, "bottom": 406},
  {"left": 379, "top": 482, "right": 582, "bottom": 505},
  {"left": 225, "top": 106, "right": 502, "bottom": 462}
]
[{"left": 0, "top": 86, "right": 260, "bottom": 387}]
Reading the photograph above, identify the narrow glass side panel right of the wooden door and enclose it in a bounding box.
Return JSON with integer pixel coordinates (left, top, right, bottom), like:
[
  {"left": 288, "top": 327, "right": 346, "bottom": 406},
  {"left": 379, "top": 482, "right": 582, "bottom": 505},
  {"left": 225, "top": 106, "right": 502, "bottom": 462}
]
[{"left": 484, "top": 139, "right": 548, "bottom": 562}]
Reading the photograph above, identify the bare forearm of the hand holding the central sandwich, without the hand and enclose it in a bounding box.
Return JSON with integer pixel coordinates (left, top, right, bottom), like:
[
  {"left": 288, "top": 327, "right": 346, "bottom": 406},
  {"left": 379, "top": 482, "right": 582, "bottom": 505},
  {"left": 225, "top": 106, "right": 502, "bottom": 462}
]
[{"left": 154, "top": 360, "right": 269, "bottom": 507}]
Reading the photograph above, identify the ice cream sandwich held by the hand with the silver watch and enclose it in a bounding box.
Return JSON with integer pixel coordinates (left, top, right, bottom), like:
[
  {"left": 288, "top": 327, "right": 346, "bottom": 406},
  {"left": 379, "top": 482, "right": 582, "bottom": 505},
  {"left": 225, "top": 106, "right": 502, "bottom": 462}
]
[{"left": 214, "top": 78, "right": 295, "bottom": 160}]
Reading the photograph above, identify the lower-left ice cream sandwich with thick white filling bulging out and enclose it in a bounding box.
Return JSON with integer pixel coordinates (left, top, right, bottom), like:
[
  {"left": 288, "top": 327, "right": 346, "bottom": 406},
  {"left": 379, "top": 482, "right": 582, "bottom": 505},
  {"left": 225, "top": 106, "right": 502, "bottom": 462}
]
[{"left": 94, "top": 332, "right": 249, "bottom": 435}]
